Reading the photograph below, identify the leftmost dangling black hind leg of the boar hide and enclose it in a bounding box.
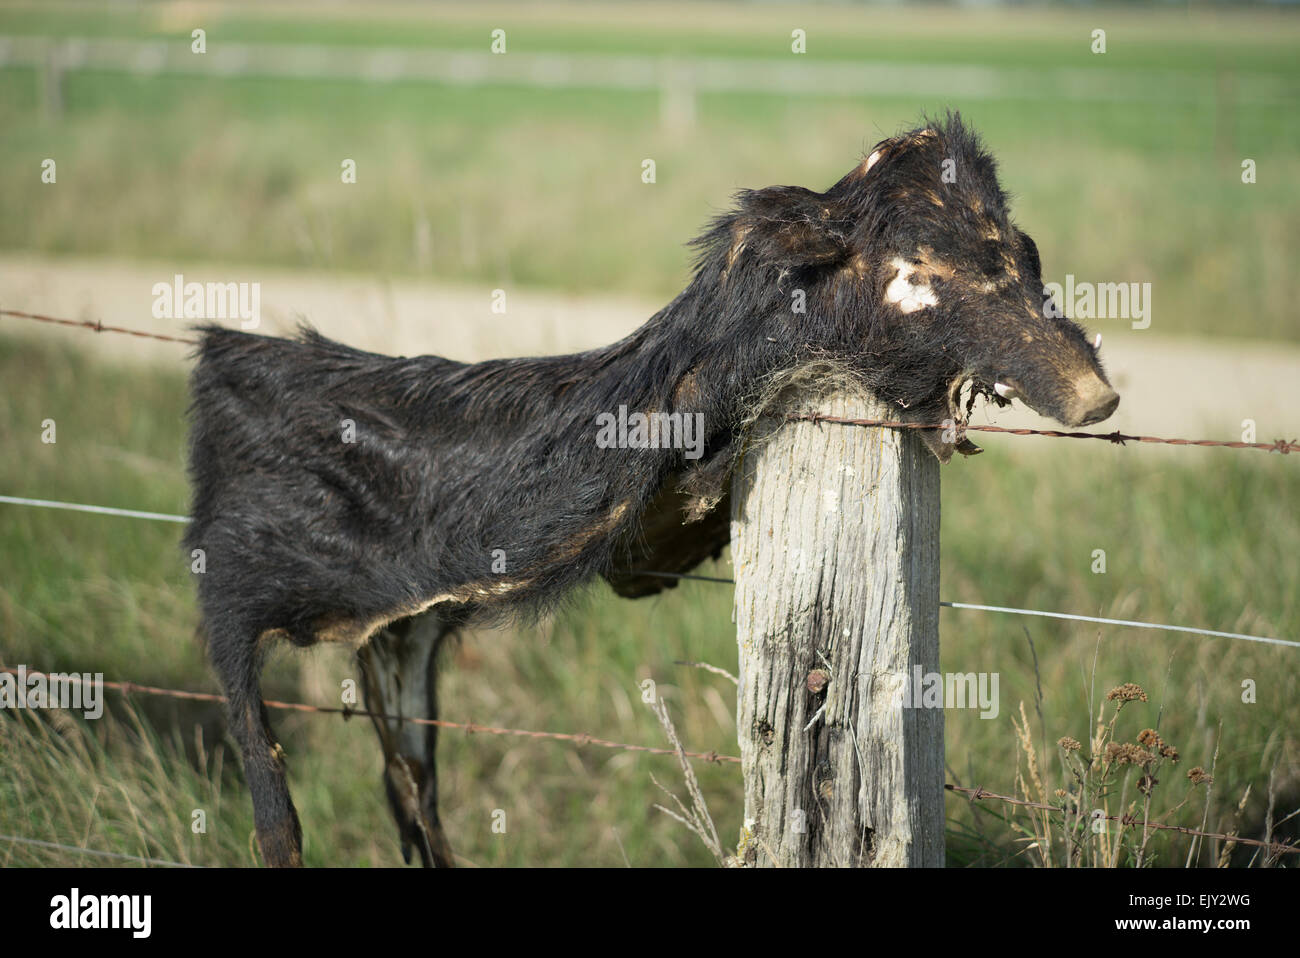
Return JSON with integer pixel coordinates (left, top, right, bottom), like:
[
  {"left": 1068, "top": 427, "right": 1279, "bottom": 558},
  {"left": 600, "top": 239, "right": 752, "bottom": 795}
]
[{"left": 209, "top": 629, "right": 303, "bottom": 868}]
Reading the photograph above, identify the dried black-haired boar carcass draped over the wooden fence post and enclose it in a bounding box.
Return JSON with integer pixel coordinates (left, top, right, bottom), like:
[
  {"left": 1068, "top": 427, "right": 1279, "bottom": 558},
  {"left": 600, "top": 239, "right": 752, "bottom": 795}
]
[{"left": 186, "top": 118, "right": 1118, "bottom": 866}]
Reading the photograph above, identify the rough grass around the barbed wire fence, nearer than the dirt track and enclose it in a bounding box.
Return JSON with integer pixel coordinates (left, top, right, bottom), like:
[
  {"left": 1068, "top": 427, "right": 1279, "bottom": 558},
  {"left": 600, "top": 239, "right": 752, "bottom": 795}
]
[{"left": 0, "top": 333, "right": 1300, "bottom": 866}]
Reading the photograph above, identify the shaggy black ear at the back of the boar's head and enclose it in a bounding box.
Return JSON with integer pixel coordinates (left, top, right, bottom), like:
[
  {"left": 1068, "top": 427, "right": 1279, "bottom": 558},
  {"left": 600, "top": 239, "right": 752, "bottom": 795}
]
[{"left": 735, "top": 186, "right": 852, "bottom": 266}]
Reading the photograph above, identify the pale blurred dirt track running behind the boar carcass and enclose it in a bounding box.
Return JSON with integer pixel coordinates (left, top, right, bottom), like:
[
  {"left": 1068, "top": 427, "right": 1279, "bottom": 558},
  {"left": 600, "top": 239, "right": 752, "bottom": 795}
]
[{"left": 0, "top": 256, "right": 1300, "bottom": 447}]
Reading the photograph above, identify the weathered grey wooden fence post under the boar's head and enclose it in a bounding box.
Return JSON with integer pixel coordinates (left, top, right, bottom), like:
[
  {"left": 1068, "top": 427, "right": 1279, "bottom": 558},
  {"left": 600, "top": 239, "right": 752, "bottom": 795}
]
[{"left": 732, "top": 389, "right": 944, "bottom": 867}]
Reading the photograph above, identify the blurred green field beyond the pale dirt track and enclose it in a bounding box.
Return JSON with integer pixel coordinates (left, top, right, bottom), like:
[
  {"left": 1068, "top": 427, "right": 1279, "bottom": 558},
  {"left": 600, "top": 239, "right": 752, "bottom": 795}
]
[{"left": 0, "top": 4, "right": 1300, "bottom": 341}]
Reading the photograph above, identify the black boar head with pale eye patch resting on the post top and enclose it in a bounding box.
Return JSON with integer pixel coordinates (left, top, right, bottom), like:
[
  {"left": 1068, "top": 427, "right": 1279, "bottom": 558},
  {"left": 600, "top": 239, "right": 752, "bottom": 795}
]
[{"left": 719, "top": 116, "right": 1119, "bottom": 461}]
